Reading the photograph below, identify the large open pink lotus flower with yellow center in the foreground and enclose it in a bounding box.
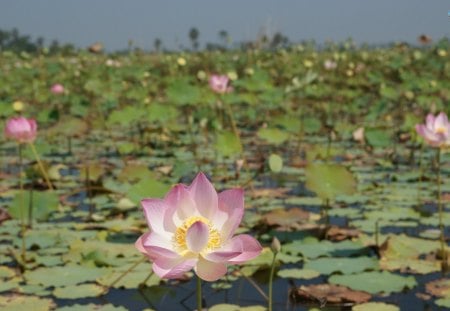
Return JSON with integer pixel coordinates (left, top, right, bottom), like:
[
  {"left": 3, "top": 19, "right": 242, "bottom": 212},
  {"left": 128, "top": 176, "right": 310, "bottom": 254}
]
[{"left": 135, "top": 173, "right": 262, "bottom": 281}]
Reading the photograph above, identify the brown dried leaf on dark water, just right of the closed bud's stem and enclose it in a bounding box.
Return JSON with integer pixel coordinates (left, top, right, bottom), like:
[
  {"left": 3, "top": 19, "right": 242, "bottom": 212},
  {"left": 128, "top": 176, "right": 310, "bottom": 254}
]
[{"left": 289, "top": 284, "right": 372, "bottom": 307}]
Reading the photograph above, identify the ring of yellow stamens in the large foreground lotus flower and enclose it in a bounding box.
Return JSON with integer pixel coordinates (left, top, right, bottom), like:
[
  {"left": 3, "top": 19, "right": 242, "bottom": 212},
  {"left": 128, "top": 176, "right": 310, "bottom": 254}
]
[{"left": 174, "top": 216, "right": 221, "bottom": 255}]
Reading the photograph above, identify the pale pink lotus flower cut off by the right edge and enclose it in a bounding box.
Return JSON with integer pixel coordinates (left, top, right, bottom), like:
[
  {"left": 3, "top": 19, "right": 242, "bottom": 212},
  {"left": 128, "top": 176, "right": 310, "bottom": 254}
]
[{"left": 416, "top": 112, "right": 450, "bottom": 147}]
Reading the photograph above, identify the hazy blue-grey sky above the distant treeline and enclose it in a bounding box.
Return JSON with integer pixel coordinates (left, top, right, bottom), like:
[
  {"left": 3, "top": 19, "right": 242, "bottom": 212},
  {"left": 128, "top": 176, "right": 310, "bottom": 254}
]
[{"left": 0, "top": 0, "right": 450, "bottom": 50}]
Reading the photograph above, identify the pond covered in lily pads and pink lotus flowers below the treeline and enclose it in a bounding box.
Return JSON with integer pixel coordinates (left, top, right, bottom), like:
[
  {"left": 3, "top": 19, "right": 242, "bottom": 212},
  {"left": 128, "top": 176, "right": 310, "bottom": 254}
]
[{"left": 0, "top": 40, "right": 450, "bottom": 311}]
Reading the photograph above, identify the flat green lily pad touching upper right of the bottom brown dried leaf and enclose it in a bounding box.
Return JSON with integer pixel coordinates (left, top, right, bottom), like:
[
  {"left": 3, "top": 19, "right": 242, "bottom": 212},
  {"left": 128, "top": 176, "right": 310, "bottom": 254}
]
[{"left": 328, "top": 271, "right": 417, "bottom": 294}]
